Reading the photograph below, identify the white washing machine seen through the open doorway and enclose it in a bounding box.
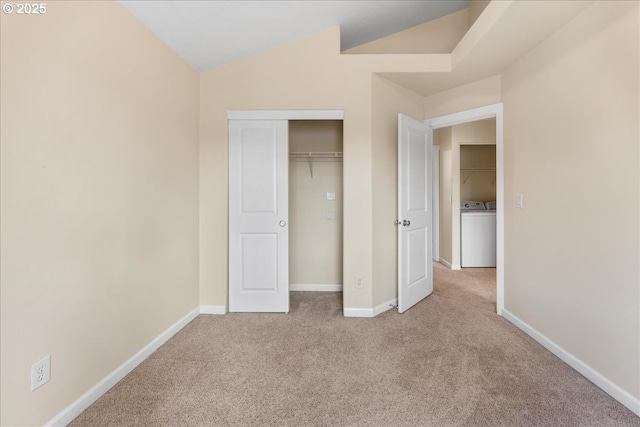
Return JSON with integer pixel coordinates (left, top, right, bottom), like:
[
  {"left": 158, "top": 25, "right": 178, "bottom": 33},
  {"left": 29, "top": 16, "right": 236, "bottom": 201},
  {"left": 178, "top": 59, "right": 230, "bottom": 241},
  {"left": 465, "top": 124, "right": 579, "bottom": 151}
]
[{"left": 460, "top": 201, "right": 496, "bottom": 267}]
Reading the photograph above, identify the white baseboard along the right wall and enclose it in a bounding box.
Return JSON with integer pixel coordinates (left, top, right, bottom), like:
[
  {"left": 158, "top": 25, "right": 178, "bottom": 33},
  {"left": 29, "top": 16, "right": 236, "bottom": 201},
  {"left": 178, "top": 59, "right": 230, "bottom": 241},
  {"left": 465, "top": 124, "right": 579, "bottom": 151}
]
[{"left": 502, "top": 309, "right": 640, "bottom": 417}]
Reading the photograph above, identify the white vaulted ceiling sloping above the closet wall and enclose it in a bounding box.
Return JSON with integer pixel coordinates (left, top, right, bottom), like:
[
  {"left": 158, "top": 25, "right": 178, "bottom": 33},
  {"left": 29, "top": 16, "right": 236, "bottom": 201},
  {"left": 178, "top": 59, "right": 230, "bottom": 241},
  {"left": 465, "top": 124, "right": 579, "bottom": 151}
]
[{"left": 119, "top": 0, "right": 469, "bottom": 71}]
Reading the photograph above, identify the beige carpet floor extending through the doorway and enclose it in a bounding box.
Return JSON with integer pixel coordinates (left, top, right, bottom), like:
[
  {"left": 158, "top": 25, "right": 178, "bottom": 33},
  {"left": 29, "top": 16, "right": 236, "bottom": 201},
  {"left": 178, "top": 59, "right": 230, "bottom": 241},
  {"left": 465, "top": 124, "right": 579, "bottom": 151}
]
[{"left": 70, "top": 264, "right": 640, "bottom": 427}]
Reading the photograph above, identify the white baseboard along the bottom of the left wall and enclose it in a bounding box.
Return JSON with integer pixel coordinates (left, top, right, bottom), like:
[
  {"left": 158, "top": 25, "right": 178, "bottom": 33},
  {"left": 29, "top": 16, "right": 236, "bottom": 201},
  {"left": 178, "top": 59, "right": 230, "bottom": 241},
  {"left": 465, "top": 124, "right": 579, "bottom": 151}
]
[{"left": 45, "top": 308, "right": 200, "bottom": 427}]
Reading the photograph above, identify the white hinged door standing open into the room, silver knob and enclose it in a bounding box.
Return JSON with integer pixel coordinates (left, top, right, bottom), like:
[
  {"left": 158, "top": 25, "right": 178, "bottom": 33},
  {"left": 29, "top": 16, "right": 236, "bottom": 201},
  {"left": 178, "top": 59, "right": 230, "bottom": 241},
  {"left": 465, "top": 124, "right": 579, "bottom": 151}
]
[{"left": 398, "top": 114, "right": 433, "bottom": 313}]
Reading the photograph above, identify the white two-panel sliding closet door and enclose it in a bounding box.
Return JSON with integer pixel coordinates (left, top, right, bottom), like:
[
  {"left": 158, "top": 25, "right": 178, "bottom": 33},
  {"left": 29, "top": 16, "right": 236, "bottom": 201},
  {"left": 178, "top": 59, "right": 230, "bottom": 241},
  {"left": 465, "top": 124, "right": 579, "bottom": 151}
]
[{"left": 229, "top": 120, "right": 289, "bottom": 312}]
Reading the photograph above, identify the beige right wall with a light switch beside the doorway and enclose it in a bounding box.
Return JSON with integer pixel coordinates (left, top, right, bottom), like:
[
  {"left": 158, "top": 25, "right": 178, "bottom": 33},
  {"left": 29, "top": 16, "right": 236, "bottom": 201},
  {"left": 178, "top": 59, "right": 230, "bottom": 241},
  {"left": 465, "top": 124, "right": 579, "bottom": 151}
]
[{"left": 502, "top": 1, "right": 640, "bottom": 399}]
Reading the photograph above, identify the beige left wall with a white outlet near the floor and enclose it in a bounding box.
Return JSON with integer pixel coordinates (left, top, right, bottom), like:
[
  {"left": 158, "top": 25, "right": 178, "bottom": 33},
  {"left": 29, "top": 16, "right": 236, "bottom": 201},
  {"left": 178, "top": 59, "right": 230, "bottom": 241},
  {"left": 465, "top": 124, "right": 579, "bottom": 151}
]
[{"left": 0, "top": 2, "right": 199, "bottom": 426}]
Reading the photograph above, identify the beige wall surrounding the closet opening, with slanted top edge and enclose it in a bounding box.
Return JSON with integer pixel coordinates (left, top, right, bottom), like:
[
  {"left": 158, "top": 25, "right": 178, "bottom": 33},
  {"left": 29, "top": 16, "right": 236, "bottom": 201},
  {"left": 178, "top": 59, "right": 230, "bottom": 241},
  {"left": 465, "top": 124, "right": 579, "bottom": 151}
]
[{"left": 200, "top": 28, "right": 448, "bottom": 308}]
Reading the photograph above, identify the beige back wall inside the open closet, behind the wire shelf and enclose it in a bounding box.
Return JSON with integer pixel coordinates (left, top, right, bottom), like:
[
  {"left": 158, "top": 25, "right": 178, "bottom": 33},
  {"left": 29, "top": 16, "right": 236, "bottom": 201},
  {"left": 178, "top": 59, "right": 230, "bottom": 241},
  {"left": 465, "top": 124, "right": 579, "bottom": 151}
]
[{"left": 289, "top": 120, "right": 342, "bottom": 285}]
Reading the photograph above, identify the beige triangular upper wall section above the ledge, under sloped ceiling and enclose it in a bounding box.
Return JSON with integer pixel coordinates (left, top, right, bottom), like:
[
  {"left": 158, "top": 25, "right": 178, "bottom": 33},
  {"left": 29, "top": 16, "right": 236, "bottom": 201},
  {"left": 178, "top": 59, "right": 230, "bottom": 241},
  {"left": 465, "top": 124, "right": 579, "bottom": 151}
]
[{"left": 343, "top": 9, "right": 469, "bottom": 54}]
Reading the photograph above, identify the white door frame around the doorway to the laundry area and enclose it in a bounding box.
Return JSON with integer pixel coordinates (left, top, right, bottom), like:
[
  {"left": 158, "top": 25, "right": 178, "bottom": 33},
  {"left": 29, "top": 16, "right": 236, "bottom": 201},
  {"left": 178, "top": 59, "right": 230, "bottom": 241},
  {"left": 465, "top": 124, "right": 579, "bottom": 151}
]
[{"left": 424, "top": 102, "right": 505, "bottom": 315}]
